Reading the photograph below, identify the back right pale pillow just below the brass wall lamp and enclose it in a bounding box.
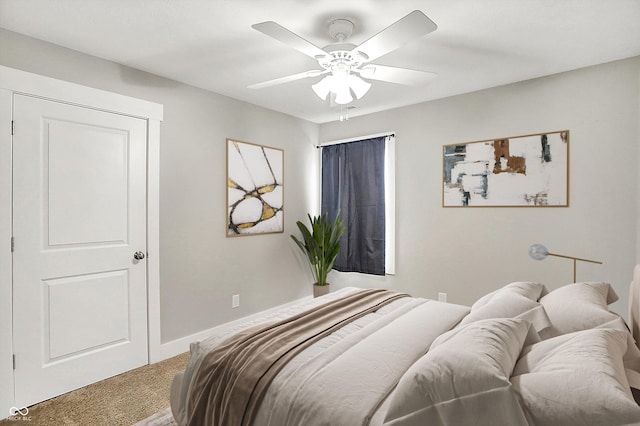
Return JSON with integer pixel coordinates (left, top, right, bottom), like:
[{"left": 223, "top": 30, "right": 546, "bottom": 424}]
[{"left": 540, "top": 282, "right": 628, "bottom": 338}]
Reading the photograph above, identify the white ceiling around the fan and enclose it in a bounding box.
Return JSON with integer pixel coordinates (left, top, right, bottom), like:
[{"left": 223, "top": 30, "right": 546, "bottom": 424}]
[{"left": 0, "top": 0, "right": 640, "bottom": 123}]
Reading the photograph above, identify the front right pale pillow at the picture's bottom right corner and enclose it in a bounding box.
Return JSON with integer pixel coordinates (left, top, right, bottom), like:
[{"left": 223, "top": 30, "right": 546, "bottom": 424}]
[{"left": 511, "top": 329, "right": 640, "bottom": 426}]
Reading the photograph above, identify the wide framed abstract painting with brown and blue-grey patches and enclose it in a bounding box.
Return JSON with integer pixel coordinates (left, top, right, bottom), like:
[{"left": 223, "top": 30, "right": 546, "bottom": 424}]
[{"left": 442, "top": 130, "right": 569, "bottom": 207}]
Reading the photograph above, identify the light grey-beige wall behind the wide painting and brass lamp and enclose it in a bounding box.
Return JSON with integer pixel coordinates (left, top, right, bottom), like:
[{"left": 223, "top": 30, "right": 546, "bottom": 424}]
[{"left": 320, "top": 58, "right": 640, "bottom": 316}]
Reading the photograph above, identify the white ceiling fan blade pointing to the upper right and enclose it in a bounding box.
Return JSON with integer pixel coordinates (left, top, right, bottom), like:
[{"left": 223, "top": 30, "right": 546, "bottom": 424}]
[{"left": 351, "top": 10, "right": 438, "bottom": 61}]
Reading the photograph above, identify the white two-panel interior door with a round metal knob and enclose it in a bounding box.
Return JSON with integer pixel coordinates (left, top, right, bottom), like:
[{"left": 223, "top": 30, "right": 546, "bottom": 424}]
[{"left": 13, "top": 95, "right": 148, "bottom": 406}]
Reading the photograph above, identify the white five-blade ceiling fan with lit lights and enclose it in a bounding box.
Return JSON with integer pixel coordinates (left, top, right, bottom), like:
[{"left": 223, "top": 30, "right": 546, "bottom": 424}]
[{"left": 248, "top": 10, "right": 438, "bottom": 105}]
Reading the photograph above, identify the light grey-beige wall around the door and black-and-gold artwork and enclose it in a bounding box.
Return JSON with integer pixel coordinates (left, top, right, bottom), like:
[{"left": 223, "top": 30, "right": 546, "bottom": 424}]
[{"left": 0, "top": 29, "right": 318, "bottom": 342}]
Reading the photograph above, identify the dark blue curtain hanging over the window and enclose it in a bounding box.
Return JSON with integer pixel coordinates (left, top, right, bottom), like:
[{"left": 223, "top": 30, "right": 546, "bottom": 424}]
[{"left": 321, "top": 136, "right": 385, "bottom": 275}]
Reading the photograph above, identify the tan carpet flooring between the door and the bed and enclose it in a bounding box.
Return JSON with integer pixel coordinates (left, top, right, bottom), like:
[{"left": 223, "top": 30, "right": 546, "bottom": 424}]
[{"left": 0, "top": 353, "right": 189, "bottom": 426}]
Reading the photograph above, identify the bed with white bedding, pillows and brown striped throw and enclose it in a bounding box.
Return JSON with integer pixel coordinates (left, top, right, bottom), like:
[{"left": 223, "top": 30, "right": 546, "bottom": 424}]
[{"left": 171, "top": 274, "right": 640, "bottom": 426}]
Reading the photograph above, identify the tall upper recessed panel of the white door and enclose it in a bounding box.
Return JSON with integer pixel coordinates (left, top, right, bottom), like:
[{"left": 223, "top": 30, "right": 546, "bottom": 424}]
[{"left": 44, "top": 118, "right": 129, "bottom": 246}]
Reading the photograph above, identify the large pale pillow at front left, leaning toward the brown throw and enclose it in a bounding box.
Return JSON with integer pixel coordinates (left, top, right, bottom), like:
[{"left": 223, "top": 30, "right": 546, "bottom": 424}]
[{"left": 384, "top": 318, "right": 539, "bottom": 426}]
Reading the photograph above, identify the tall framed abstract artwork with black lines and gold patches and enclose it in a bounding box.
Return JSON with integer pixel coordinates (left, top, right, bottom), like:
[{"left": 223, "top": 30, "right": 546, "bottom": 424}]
[{"left": 227, "top": 139, "right": 284, "bottom": 237}]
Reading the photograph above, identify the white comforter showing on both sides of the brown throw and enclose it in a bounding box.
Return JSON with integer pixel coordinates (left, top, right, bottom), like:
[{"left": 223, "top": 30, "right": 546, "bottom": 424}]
[{"left": 172, "top": 288, "right": 469, "bottom": 426}]
